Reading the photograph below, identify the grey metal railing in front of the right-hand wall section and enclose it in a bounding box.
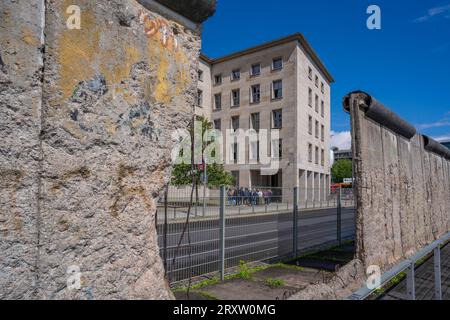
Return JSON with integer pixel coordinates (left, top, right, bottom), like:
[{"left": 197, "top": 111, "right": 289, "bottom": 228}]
[{"left": 348, "top": 232, "right": 450, "bottom": 300}]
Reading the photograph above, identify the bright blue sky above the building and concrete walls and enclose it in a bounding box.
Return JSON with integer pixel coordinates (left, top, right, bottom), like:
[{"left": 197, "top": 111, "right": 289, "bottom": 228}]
[{"left": 203, "top": 0, "right": 450, "bottom": 148}]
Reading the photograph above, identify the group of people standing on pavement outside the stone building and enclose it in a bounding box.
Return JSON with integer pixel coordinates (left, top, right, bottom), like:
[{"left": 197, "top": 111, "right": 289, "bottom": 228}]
[{"left": 227, "top": 188, "right": 273, "bottom": 206}]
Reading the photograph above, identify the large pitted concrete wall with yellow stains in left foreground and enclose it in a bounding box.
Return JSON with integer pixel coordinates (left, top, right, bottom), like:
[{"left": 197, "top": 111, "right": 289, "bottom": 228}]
[{"left": 0, "top": 0, "right": 212, "bottom": 299}]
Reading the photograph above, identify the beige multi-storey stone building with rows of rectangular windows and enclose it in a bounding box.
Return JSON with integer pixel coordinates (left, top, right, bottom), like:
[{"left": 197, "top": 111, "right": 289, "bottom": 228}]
[{"left": 196, "top": 34, "right": 334, "bottom": 201}]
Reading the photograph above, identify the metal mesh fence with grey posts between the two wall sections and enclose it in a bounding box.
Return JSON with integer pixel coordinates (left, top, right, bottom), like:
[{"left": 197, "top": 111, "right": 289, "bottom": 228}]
[{"left": 157, "top": 188, "right": 355, "bottom": 284}]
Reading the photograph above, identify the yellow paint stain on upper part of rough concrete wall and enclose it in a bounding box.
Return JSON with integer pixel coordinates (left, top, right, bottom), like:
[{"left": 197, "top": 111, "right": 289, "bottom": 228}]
[{"left": 57, "top": 0, "right": 190, "bottom": 104}]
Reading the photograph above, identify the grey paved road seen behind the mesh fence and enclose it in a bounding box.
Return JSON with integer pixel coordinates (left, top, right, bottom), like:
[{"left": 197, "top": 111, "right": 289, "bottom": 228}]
[{"left": 158, "top": 208, "right": 355, "bottom": 282}]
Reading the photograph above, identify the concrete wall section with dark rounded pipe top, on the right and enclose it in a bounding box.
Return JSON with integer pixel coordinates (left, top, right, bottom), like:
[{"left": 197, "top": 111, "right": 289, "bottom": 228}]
[{"left": 344, "top": 92, "right": 450, "bottom": 269}]
